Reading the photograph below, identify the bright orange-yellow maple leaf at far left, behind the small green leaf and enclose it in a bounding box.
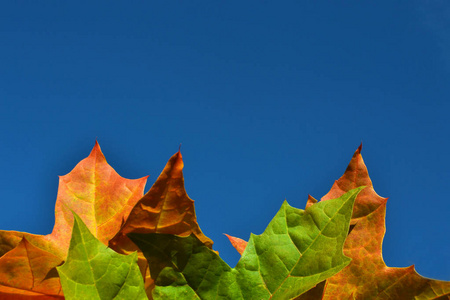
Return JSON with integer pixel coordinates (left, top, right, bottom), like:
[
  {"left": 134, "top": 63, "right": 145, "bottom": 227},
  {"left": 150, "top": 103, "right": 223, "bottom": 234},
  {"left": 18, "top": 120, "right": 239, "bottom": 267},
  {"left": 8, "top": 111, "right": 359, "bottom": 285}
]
[{"left": 0, "top": 142, "right": 147, "bottom": 299}]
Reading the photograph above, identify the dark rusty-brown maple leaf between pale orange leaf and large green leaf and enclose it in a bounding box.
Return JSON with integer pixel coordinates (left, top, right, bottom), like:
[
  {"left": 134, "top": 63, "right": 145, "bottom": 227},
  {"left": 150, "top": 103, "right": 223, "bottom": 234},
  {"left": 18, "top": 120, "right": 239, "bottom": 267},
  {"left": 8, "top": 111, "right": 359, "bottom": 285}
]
[{"left": 109, "top": 151, "right": 213, "bottom": 297}]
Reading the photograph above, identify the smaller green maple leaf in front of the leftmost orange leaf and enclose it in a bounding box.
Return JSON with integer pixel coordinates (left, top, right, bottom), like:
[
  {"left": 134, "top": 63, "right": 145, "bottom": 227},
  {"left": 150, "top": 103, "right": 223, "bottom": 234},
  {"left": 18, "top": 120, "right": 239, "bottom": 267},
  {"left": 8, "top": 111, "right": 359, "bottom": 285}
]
[{"left": 57, "top": 213, "right": 147, "bottom": 299}]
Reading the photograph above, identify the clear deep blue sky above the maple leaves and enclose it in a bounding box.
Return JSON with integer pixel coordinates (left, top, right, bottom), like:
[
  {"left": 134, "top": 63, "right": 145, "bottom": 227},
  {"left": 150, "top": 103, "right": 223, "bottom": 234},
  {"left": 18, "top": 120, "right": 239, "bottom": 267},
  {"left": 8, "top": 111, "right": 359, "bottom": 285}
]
[{"left": 0, "top": 1, "right": 450, "bottom": 280}]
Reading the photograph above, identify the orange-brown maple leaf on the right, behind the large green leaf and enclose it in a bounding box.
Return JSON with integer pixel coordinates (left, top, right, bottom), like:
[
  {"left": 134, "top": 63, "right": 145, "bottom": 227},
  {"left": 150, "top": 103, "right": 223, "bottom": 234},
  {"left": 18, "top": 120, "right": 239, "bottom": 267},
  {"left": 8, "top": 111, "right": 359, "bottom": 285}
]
[{"left": 316, "top": 146, "right": 450, "bottom": 299}]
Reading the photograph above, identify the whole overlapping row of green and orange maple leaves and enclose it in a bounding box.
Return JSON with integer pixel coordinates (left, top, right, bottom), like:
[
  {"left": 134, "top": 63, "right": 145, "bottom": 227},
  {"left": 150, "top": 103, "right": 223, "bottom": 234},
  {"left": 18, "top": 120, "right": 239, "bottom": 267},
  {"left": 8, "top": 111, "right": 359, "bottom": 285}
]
[{"left": 0, "top": 143, "right": 450, "bottom": 299}]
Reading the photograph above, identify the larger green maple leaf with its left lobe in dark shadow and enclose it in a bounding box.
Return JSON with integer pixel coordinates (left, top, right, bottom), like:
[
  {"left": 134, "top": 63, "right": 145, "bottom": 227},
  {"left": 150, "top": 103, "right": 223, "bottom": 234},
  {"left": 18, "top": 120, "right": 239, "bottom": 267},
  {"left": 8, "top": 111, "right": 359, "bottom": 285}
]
[{"left": 128, "top": 187, "right": 362, "bottom": 300}]
